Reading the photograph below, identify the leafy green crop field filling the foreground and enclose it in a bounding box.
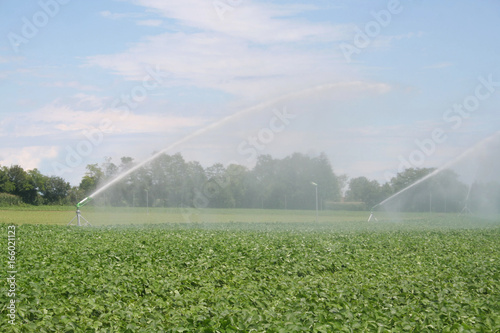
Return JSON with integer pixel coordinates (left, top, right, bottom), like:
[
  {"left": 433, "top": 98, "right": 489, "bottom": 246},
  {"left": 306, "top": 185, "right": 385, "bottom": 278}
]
[{"left": 0, "top": 214, "right": 500, "bottom": 332}]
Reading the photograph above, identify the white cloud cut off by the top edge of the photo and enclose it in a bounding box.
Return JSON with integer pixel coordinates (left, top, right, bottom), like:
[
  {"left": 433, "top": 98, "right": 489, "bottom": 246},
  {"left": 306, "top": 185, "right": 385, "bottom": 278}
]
[{"left": 129, "top": 0, "right": 345, "bottom": 43}]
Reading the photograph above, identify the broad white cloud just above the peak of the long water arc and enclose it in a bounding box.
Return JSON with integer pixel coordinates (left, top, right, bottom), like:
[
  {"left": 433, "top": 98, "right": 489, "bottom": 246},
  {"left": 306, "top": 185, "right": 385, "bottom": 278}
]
[{"left": 88, "top": 33, "right": 356, "bottom": 99}]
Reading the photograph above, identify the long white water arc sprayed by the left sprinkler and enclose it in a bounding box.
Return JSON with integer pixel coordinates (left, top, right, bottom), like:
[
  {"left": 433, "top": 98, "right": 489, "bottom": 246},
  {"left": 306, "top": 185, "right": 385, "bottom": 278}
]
[{"left": 77, "top": 82, "right": 352, "bottom": 207}]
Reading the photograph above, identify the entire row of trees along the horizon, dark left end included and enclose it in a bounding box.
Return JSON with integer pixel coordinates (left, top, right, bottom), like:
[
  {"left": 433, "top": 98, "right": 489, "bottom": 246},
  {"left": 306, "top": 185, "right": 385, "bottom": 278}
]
[{"left": 0, "top": 153, "right": 500, "bottom": 212}]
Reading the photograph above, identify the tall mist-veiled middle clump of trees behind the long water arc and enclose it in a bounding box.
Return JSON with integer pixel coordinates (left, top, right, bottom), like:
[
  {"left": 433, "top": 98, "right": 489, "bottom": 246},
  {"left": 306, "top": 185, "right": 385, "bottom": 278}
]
[{"left": 80, "top": 153, "right": 341, "bottom": 209}]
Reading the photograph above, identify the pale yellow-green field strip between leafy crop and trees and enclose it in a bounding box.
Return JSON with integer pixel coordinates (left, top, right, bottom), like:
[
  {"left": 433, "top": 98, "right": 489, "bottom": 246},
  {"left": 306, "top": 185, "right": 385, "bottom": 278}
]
[{"left": 0, "top": 206, "right": 492, "bottom": 226}]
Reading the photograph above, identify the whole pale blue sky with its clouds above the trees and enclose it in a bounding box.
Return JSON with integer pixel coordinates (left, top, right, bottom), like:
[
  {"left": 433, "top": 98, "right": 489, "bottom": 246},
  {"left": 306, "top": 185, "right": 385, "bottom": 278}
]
[{"left": 0, "top": 0, "right": 500, "bottom": 185}]
